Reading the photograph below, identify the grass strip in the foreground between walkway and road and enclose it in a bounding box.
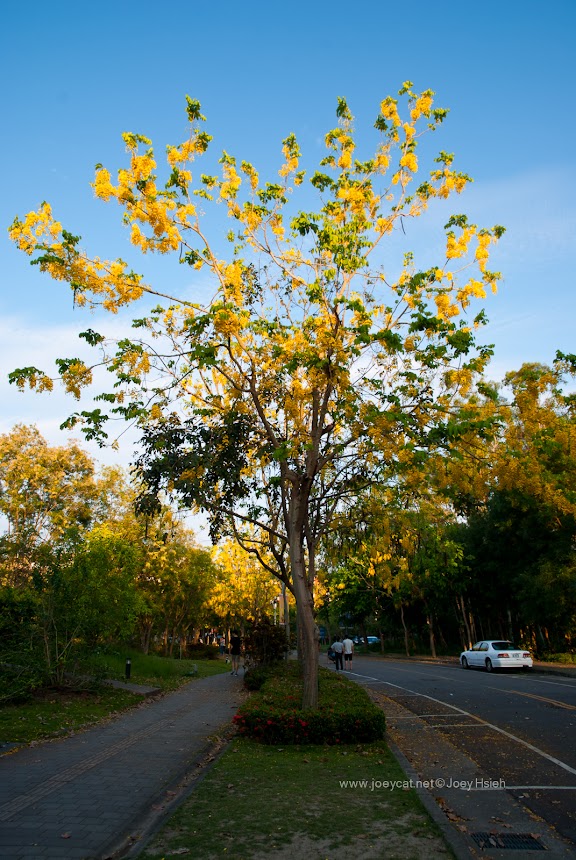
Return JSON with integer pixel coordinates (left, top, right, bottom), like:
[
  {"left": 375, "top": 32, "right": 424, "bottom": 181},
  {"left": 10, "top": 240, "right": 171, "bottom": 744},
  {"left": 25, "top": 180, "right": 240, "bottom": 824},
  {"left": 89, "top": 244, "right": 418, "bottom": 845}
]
[{"left": 139, "top": 739, "right": 453, "bottom": 860}]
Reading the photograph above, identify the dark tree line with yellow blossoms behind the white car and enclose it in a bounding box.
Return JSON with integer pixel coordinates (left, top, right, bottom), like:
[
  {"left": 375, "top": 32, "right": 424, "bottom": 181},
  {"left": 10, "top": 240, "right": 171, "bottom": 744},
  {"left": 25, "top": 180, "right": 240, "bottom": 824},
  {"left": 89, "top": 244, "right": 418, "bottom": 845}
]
[{"left": 320, "top": 355, "right": 576, "bottom": 656}]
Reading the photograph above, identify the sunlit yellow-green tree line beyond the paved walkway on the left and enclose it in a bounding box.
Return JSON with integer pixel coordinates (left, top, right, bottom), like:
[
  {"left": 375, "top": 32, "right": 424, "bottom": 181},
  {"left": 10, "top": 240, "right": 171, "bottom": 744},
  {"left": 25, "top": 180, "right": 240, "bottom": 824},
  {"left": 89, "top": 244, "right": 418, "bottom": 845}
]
[{"left": 0, "top": 425, "right": 278, "bottom": 700}]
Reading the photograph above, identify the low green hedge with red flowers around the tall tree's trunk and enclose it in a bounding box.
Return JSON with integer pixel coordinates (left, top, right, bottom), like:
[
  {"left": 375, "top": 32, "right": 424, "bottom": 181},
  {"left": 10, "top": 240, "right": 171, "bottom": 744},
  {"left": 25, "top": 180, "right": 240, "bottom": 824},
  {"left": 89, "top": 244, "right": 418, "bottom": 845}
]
[{"left": 234, "top": 663, "right": 386, "bottom": 744}]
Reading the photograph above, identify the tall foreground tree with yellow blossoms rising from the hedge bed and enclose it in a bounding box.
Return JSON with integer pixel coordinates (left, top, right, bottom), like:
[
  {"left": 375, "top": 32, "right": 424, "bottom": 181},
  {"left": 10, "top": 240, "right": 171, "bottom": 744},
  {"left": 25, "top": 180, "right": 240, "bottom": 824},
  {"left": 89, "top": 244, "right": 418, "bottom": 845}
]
[{"left": 11, "top": 82, "right": 503, "bottom": 707}]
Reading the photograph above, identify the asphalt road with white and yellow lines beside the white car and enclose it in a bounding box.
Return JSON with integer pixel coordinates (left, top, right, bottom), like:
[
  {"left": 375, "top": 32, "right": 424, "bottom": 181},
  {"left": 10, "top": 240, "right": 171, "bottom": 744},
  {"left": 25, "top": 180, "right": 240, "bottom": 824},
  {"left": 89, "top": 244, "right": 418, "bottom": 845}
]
[{"left": 351, "top": 657, "right": 576, "bottom": 846}]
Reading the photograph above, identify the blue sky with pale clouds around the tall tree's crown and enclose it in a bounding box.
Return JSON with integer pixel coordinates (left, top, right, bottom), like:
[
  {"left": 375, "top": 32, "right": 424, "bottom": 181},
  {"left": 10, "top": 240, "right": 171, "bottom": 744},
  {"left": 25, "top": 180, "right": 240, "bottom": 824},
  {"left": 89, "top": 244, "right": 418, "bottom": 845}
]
[{"left": 0, "top": 0, "right": 576, "bottom": 470}]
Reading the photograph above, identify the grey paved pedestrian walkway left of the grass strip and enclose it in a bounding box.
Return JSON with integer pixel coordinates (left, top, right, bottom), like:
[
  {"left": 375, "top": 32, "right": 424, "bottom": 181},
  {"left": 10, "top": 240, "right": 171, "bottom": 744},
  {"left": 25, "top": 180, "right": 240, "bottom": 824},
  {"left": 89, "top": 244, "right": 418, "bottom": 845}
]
[{"left": 0, "top": 674, "right": 242, "bottom": 860}]
